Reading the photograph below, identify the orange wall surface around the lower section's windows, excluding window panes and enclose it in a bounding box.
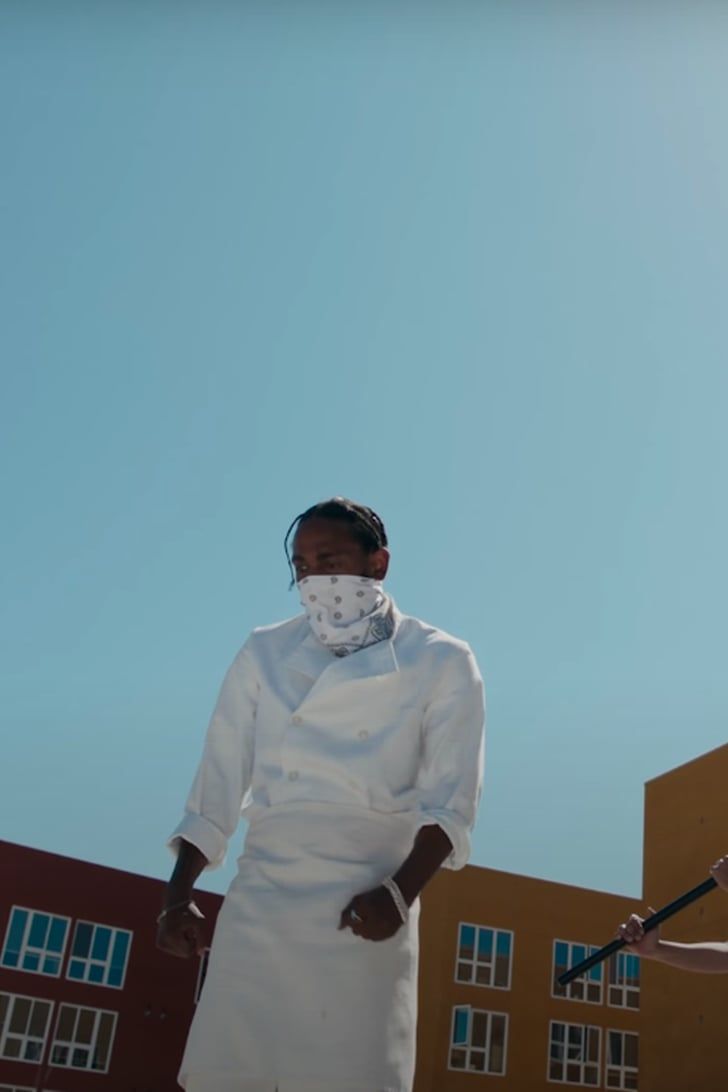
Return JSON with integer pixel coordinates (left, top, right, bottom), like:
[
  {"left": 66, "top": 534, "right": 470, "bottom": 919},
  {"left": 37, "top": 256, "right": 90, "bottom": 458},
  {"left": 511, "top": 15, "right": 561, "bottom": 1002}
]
[{"left": 415, "top": 867, "right": 642, "bottom": 1092}]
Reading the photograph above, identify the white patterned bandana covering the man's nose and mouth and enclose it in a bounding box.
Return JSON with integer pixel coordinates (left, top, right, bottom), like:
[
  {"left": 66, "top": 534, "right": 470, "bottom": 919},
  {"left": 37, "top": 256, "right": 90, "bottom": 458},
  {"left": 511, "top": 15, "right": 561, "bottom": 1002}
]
[{"left": 298, "top": 575, "right": 394, "bottom": 656}]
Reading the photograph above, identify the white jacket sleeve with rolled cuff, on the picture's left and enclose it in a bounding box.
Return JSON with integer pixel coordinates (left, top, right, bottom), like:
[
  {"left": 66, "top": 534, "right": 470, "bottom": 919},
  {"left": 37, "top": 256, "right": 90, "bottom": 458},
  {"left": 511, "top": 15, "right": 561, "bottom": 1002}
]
[{"left": 167, "top": 641, "right": 259, "bottom": 868}]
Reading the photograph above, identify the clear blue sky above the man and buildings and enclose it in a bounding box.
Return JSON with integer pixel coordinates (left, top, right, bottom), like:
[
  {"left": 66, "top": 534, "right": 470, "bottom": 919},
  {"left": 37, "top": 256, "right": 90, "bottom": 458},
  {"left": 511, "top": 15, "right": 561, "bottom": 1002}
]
[{"left": 0, "top": 0, "right": 728, "bottom": 895}]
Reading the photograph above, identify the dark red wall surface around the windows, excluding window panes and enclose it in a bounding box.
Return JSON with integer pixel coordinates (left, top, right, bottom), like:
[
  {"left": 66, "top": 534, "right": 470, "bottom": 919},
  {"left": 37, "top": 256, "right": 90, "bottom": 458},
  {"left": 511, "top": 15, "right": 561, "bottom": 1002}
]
[{"left": 0, "top": 842, "right": 222, "bottom": 1092}]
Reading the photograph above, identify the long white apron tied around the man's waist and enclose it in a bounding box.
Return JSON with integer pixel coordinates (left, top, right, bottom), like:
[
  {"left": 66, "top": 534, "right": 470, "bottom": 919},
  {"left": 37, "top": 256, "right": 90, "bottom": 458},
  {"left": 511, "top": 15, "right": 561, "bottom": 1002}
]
[{"left": 179, "top": 803, "right": 419, "bottom": 1092}]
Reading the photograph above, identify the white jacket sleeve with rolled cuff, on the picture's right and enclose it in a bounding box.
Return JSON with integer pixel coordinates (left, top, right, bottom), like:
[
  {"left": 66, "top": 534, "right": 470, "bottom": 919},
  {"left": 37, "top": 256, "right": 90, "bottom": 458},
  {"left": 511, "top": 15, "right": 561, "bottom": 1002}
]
[{"left": 417, "top": 645, "right": 486, "bottom": 868}]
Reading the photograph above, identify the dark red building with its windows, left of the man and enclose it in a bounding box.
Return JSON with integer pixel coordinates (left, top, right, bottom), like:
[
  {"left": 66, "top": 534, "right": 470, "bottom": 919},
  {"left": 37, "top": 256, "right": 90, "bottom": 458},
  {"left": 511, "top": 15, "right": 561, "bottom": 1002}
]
[{"left": 0, "top": 842, "right": 222, "bottom": 1092}]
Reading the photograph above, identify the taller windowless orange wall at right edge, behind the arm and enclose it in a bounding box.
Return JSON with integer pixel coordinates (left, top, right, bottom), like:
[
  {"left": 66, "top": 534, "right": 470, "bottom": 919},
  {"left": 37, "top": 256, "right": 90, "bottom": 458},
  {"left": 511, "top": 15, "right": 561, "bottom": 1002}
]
[{"left": 642, "top": 745, "right": 728, "bottom": 1092}]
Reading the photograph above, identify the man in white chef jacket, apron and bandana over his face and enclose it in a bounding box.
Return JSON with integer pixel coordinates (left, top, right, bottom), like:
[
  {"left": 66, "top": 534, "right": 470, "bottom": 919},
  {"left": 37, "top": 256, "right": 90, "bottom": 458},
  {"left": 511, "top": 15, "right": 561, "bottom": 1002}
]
[{"left": 158, "top": 497, "right": 484, "bottom": 1092}]
